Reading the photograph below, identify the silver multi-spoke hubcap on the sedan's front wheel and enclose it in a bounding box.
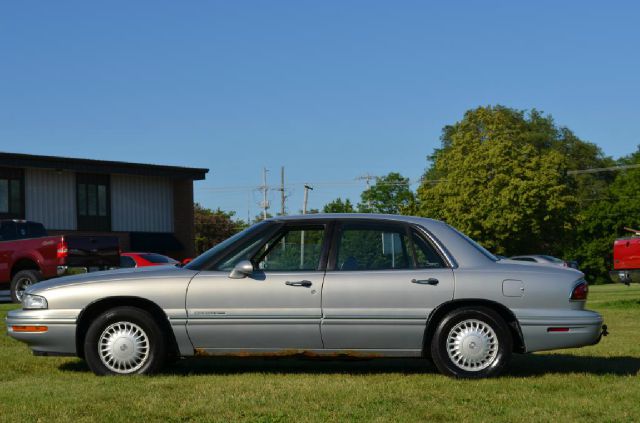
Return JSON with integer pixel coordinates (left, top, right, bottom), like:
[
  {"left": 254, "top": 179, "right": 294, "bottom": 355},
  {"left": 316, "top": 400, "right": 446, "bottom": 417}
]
[{"left": 98, "top": 322, "right": 149, "bottom": 374}]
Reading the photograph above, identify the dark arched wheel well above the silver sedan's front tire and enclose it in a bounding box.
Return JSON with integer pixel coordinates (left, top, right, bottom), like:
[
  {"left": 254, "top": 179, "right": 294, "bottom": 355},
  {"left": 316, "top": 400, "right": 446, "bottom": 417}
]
[{"left": 76, "top": 297, "right": 179, "bottom": 358}]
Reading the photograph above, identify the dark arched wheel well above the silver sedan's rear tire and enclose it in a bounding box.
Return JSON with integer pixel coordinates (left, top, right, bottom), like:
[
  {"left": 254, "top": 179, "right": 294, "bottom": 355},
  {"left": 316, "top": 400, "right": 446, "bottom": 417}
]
[{"left": 423, "top": 299, "right": 525, "bottom": 356}]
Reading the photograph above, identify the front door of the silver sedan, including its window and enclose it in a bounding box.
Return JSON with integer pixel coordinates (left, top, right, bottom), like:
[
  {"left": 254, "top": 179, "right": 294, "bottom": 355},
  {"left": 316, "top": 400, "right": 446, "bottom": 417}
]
[{"left": 187, "top": 224, "right": 325, "bottom": 354}]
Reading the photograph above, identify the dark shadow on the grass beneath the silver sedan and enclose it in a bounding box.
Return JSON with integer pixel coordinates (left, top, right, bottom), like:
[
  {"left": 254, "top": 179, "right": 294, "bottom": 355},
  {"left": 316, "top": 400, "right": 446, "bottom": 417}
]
[{"left": 60, "top": 354, "right": 640, "bottom": 377}]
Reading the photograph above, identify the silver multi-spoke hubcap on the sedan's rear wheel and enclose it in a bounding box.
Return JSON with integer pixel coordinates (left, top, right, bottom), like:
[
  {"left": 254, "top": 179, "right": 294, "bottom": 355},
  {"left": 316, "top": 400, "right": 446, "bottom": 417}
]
[{"left": 447, "top": 319, "right": 498, "bottom": 372}]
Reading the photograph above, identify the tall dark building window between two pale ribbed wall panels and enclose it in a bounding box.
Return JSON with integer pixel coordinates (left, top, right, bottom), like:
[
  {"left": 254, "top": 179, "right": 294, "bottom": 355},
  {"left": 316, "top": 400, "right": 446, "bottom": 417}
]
[{"left": 76, "top": 173, "right": 111, "bottom": 231}]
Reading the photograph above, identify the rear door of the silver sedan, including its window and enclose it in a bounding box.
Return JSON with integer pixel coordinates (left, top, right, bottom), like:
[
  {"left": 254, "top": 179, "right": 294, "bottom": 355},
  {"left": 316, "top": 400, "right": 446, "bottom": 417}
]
[{"left": 322, "top": 222, "right": 454, "bottom": 355}]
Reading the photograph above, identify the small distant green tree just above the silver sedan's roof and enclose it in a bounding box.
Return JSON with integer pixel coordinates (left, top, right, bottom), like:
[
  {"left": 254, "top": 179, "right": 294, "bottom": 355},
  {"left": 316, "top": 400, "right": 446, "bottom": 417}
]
[{"left": 358, "top": 172, "right": 414, "bottom": 214}]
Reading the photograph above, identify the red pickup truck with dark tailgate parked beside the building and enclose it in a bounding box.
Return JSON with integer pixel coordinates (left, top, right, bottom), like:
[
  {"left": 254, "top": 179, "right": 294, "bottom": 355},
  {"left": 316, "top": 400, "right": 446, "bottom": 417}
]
[{"left": 0, "top": 220, "right": 120, "bottom": 302}]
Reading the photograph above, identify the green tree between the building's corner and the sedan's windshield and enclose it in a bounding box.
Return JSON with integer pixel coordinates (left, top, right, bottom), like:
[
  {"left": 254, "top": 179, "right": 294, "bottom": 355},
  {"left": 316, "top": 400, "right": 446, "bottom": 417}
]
[{"left": 194, "top": 203, "right": 247, "bottom": 254}]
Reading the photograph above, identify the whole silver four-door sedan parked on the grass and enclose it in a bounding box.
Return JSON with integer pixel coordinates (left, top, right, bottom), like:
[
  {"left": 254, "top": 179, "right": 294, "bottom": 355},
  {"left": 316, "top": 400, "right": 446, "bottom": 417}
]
[{"left": 7, "top": 214, "right": 604, "bottom": 378}]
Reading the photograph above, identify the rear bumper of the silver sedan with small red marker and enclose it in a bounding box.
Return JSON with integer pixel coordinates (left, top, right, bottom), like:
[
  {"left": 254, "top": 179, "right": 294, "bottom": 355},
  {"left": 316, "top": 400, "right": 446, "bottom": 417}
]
[{"left": 519, "top": 310, "right": 608, "bottom": 352}]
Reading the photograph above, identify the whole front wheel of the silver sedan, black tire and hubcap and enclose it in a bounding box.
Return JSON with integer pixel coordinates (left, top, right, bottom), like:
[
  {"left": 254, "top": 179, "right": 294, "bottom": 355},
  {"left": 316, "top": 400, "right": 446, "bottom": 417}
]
[{"left": 84, "top": 307, "right": 167, "bottom": 376}]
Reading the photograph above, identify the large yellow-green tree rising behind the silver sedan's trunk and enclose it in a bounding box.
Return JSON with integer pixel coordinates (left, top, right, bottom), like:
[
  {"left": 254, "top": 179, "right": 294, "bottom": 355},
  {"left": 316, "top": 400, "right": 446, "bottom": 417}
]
[{"left": 416, "top": 106, "right": 602, "bottom": 255}]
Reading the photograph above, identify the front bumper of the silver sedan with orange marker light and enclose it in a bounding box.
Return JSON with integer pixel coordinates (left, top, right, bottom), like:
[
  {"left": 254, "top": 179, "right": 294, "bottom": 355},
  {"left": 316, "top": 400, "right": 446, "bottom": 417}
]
[{"left": 6, "top": 310, "right": 76, "bottom": 355}]
